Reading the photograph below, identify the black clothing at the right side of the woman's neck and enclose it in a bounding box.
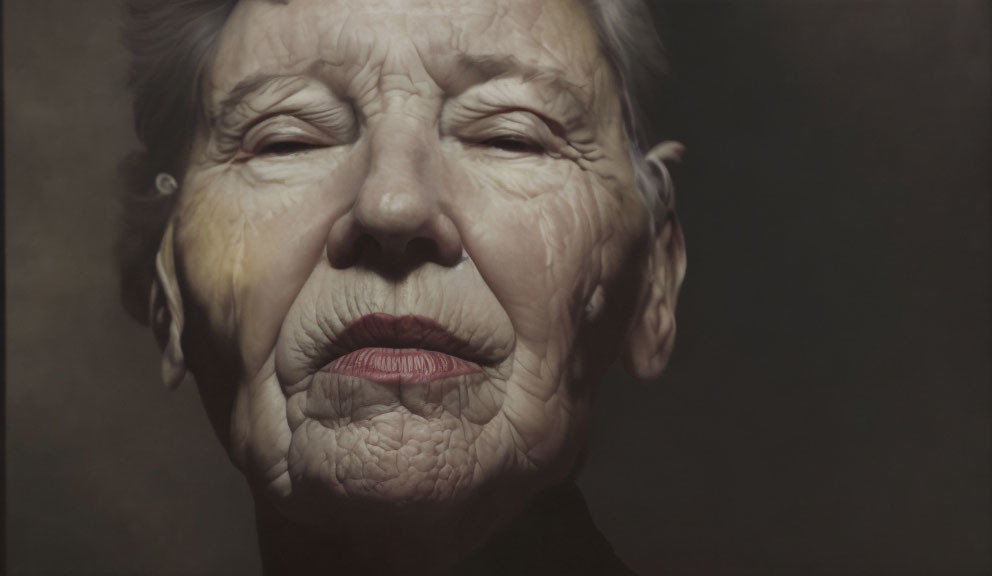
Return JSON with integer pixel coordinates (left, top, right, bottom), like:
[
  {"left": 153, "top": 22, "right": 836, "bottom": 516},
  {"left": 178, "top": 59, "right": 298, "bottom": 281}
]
[{"left": 449, "top": 482, "right": 636, "bottom": 576}]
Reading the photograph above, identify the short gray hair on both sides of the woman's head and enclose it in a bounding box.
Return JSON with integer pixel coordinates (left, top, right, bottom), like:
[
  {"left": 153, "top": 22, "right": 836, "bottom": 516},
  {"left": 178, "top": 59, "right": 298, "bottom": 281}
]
[{"left": 116, "top": 0, "right": 666, "bottom": 324}]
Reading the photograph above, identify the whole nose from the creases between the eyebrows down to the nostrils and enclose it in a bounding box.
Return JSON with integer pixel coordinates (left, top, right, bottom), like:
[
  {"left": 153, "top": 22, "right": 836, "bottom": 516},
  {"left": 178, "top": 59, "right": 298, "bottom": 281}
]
[{"left": 327, "top": 48, "right": 463, "bottom": 273}]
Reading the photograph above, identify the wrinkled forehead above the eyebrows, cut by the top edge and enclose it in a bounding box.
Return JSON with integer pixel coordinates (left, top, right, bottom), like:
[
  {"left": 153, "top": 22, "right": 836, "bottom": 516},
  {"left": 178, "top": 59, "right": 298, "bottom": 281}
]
[{"left": 206, "top": 0, "right": 606, "bottom": 103}]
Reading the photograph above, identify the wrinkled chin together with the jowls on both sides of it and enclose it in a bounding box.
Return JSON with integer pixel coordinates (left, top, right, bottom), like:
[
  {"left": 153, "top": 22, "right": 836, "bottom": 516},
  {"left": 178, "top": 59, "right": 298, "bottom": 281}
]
[{"left": 232, "top": 352, "right": 588, "bottom": 537}]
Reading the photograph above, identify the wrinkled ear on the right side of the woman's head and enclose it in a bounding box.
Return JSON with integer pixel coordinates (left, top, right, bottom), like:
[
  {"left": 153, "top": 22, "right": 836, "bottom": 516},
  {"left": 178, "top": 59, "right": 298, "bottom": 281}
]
[{"left": 625, "top": 142, "right": 686, "bottom": 380}]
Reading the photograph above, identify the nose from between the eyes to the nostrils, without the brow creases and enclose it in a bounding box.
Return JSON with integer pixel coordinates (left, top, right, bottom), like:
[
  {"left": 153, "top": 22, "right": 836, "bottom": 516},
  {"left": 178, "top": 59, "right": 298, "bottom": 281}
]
[{"left": 327, "top": 125, "right": 462, "bottom": 271}]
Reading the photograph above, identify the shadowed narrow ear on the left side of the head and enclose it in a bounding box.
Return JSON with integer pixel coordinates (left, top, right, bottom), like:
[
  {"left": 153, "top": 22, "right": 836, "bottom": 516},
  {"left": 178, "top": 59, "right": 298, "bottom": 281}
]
[{"left": 150, "top": 221, "right": 186, "bottom": 388}]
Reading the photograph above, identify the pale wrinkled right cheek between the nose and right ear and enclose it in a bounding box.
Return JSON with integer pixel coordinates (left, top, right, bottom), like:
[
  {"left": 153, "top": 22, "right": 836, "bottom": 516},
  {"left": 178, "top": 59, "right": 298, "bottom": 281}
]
[{"left": 454, "top": 159, "right": 609, "bottom": 345}]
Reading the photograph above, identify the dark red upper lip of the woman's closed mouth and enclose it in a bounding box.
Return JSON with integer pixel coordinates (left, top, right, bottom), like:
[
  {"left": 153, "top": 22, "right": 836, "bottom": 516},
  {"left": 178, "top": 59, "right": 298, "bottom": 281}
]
[{"left": 322, "top": 313, "right": 494, "bottom": 365}]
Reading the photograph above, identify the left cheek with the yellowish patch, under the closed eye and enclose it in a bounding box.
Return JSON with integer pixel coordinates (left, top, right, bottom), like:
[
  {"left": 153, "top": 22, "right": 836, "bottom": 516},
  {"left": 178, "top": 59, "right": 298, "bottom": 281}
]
[{"left": 177, "top": 151, "right": 364, "bottom": 374}]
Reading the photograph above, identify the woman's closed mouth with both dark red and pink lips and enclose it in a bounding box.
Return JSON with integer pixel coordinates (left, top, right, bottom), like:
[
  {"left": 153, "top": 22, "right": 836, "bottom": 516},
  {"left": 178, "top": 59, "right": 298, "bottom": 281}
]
[{"left": 321, "top": 314, "right": 486, "bottom": 384}]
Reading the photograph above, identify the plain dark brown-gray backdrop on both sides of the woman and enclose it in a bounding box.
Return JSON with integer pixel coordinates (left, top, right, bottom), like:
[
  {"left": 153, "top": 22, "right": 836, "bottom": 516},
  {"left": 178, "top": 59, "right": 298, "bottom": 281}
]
[{"left": 3, "top": 0, "right": 992, "bottom": 576}]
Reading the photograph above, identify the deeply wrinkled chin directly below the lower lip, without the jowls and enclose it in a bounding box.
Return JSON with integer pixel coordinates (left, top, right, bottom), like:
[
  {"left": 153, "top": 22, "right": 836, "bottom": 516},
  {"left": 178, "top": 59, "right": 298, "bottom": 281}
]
[{"left": 260, "top": 372, "right": 520, "bottom": 525}]
